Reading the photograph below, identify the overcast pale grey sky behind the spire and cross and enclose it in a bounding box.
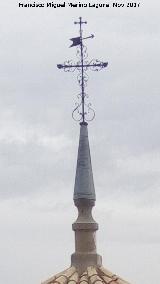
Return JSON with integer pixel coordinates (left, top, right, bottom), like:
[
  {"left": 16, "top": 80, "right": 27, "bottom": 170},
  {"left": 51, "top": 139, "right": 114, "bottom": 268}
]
[{"left": 0, "top": 0, "right": 160, "bottom": 284}]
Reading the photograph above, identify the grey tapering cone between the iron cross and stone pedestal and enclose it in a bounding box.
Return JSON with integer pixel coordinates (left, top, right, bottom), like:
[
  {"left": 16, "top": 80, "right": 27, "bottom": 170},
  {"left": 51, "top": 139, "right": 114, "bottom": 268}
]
[{"left": 74, "top": 123, "right": 96, "bottom": 201}]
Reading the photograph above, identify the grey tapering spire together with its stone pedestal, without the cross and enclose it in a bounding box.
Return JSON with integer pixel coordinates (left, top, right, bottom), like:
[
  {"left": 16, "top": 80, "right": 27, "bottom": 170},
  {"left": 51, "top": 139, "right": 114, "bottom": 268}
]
[{"left": 71, "top": 125, "right": 102, "bottom": 274}]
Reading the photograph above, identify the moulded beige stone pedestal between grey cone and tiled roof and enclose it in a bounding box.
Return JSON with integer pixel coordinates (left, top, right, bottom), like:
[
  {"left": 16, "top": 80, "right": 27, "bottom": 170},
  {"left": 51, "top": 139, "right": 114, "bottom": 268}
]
[{"left": 71, "top": 199, "right": 102, "bottom": 273}]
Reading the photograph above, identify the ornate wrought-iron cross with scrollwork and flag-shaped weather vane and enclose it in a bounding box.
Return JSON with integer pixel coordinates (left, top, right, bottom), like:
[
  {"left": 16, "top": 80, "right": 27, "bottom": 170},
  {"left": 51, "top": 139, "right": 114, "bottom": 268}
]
[{"left": 57, "top": 17, "right": 108, "bottom": 124}]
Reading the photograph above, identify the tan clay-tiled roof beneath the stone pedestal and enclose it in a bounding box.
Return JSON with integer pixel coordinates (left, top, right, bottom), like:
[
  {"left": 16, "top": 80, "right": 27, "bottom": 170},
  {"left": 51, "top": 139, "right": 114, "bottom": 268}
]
[{"left": 42, "top": 266, "right": 129, "bottom": 284}]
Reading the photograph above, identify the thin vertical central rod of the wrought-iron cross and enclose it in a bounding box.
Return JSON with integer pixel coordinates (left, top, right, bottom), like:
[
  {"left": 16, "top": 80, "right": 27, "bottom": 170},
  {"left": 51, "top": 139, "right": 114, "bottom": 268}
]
[{"left": 79, "top": 17, "right": 85, "bottom": 123}]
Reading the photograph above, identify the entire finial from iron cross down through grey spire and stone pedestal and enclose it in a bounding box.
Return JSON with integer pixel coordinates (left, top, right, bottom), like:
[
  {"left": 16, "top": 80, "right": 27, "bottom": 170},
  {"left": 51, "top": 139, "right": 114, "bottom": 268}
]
[{"left": 57, "top": 17, "right": 108, "bottom": 273}]
